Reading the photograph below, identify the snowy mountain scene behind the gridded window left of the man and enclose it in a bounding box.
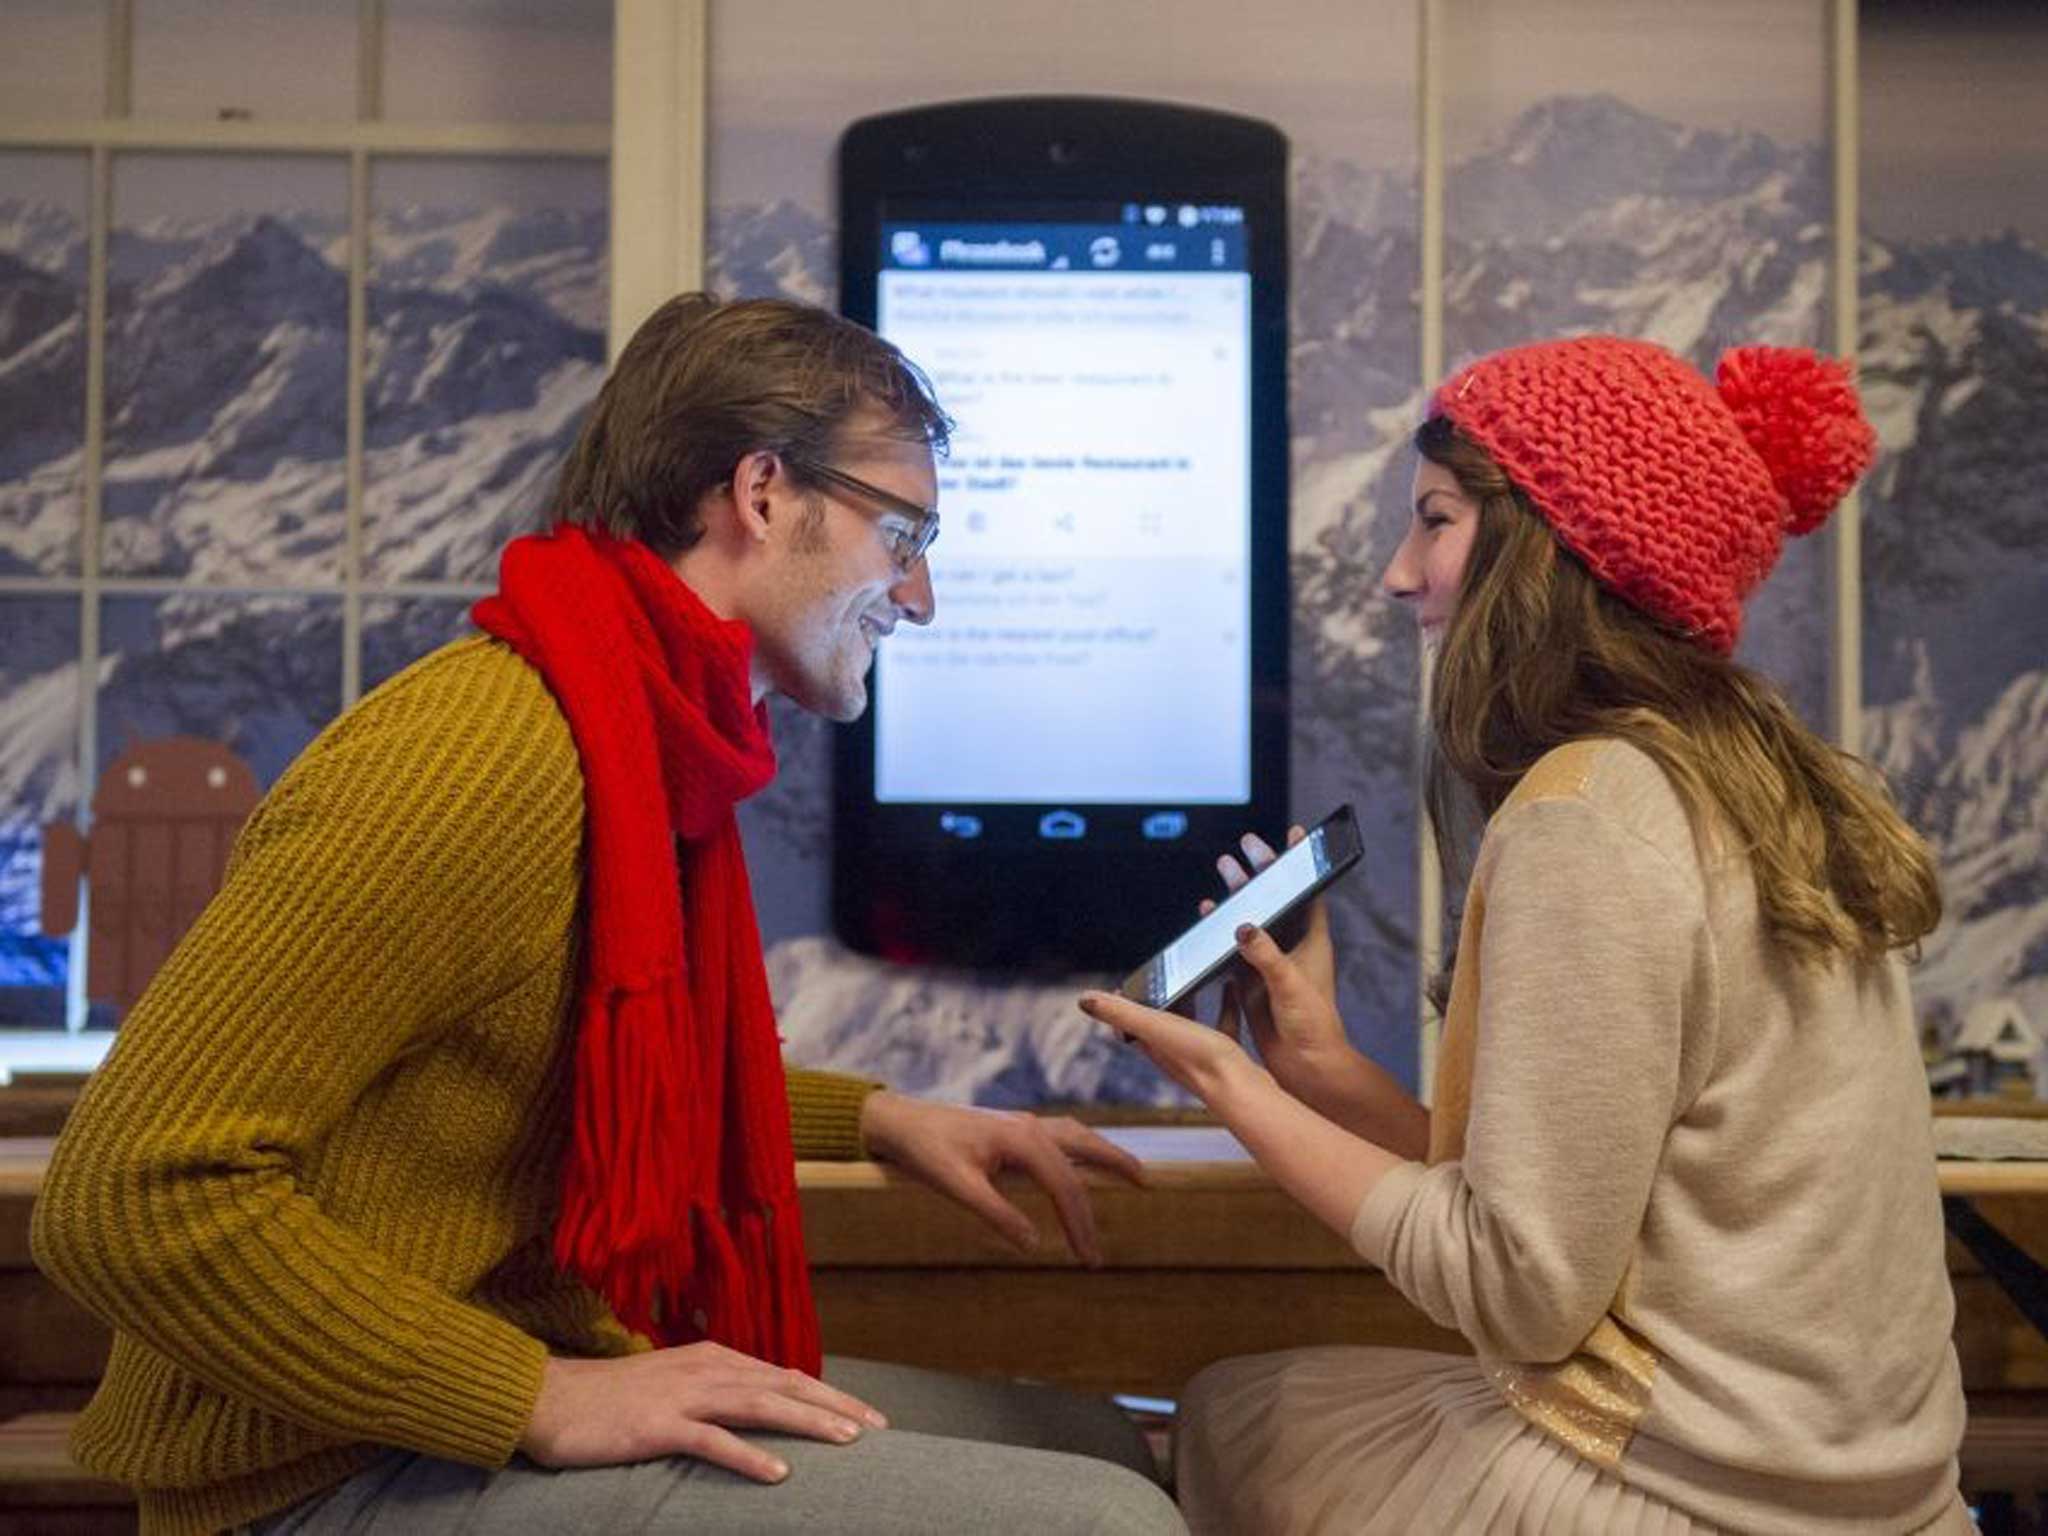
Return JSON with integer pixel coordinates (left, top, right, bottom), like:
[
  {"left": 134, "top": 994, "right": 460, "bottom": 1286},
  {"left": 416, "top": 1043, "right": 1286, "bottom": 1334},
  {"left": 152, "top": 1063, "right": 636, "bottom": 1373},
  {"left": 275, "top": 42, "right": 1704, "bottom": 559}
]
[{"left": 0, "top": 198, "right": 608, "bottom": 1028}]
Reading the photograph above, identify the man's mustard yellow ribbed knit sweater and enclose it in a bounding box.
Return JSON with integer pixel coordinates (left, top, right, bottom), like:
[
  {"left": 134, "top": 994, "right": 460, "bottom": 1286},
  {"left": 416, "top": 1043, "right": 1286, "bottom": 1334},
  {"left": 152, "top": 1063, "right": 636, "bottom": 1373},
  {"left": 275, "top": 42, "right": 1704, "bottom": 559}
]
[{"left": 33, "top": 639, "right": 872, "bottom": 1532}]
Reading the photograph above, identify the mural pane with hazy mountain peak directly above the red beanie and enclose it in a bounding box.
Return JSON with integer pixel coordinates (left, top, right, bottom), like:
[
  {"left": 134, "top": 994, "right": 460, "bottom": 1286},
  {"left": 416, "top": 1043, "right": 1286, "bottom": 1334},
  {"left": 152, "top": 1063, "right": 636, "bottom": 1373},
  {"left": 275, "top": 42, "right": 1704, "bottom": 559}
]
[{"left": 1444, "top": 0, "right": 1833, "bottom": 729}]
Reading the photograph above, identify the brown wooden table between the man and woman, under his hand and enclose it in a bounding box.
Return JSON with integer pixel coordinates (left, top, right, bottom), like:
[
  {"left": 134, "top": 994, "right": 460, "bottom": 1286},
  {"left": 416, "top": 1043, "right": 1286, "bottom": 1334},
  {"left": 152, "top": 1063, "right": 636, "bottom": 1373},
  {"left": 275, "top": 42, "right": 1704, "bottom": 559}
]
[{"left": 799, "top": 1126, "right": 2048, "bottom": 1397}]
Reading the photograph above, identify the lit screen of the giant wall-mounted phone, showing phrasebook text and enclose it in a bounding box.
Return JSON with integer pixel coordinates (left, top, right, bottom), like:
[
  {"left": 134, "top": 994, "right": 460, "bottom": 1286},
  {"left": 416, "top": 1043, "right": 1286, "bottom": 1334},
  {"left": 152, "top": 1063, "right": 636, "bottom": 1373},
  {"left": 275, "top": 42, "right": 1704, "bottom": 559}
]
[{"left": 874, "top": 205, "right": 1251, "bottom": 807}]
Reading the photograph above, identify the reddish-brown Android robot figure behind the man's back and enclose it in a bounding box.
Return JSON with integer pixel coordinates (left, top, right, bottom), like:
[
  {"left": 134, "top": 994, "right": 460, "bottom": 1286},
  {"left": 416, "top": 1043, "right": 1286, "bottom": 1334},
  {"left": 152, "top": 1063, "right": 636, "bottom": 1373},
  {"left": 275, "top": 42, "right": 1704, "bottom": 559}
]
[{"left": 43, "top": 735, "right": 262, "bottom": 1012}]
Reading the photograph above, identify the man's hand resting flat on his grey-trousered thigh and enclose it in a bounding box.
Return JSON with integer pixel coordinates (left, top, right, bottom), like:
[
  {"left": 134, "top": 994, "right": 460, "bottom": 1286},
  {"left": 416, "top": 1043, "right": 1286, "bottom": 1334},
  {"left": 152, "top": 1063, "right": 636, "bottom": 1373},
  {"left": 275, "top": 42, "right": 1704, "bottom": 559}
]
[{"left": 518, "top": 1343, "right": 889, "bottom": 1483}]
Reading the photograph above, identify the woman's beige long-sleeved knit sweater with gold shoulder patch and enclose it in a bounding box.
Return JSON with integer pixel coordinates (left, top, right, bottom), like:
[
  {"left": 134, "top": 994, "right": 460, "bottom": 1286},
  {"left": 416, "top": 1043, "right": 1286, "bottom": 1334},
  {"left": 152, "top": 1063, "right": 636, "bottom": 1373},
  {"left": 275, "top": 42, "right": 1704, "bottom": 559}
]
[{"left": 1352, "top": 741, "right": 1964, "bottom": 1532}]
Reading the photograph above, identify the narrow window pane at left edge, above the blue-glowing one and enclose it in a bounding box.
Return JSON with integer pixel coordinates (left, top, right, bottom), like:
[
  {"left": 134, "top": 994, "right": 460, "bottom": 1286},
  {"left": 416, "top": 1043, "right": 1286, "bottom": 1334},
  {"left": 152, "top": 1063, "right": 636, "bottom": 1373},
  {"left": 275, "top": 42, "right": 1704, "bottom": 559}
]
[{"left": 0, "top": 154, "right": 90, "bottom": 575}]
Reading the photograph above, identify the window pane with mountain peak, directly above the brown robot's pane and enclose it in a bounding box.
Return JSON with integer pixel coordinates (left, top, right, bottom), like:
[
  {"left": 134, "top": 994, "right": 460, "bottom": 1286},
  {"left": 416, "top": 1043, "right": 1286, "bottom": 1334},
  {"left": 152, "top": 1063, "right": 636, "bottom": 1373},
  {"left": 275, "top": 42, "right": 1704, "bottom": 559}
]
[{"left": 100, "top": 154, "right": 348, "bottom": 584}]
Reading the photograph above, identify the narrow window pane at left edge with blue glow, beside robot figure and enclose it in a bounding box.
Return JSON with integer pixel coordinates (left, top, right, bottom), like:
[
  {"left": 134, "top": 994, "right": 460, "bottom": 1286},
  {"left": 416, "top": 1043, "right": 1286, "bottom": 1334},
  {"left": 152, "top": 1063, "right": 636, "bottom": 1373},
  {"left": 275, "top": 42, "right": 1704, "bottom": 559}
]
[{"left": 0, "top": 596, "right": 80, "bottom": 1030}]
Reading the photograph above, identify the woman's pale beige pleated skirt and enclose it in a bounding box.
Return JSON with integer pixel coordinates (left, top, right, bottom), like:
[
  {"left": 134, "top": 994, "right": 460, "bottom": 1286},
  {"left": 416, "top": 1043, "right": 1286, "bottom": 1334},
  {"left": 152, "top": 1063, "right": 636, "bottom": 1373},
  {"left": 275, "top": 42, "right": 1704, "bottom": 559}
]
[{"left": 1174, "top": 1348, "right": 1970, "bottom": 1536}]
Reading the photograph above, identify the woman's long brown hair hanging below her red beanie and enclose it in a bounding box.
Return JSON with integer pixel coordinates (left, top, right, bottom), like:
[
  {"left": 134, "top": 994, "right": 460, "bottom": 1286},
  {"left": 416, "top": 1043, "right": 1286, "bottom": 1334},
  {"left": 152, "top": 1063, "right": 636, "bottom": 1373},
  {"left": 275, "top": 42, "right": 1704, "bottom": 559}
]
[{"left": 1415, "top": 416, "right": 1942, "bottom": 1003}]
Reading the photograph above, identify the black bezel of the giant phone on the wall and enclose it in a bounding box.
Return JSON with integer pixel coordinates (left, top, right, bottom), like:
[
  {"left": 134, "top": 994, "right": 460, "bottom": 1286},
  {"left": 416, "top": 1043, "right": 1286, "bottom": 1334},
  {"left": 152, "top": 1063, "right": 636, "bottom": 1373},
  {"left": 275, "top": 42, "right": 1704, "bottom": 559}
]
[{"left": 831, "top": 96, "right": 1288, "bottom": 971}]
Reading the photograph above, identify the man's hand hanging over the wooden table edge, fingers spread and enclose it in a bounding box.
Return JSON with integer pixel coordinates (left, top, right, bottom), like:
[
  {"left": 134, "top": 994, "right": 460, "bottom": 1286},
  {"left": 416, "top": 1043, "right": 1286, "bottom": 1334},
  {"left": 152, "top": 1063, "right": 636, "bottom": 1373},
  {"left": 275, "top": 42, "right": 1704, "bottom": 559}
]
[{"left": 860, "top": 1092, "right": 1145, "bottom": 1264}]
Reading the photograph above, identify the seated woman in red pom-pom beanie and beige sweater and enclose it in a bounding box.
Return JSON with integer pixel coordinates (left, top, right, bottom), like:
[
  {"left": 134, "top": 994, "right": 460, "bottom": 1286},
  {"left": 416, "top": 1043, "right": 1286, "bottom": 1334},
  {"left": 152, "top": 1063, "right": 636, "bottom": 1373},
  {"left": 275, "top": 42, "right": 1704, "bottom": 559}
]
[{"left": 1083, "top": 338, "right": 1970, "bottom": 1536}]
